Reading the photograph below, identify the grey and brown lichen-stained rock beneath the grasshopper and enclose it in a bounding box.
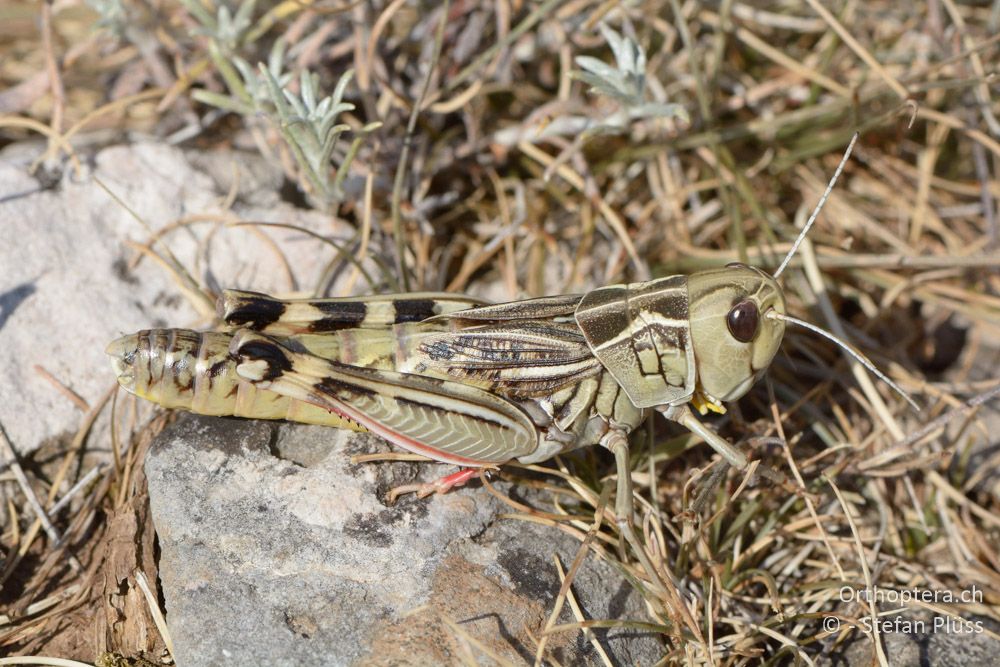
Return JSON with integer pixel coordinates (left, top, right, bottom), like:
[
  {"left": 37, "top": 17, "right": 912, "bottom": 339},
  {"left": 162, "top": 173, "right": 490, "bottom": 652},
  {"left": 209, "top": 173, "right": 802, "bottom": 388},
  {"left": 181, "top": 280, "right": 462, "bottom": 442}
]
[{"left": 146, "top": 416, "right": 663, "bottom": 667}]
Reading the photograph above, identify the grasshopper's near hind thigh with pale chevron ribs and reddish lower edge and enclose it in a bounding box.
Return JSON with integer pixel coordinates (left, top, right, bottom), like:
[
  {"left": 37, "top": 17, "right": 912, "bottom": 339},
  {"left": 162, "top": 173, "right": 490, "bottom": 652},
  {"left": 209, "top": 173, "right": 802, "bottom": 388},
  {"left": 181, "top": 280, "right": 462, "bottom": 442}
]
[{"left": 230, "top": 331, "right": 538, "bottom": 466}]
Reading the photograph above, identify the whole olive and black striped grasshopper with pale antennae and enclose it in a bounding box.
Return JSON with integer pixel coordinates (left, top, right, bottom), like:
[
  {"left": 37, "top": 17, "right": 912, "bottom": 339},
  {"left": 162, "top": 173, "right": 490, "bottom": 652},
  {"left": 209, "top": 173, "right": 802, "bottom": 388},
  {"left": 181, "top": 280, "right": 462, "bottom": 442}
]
[{"left": 107, "top": 136, "right": 908, "bottom": 522}]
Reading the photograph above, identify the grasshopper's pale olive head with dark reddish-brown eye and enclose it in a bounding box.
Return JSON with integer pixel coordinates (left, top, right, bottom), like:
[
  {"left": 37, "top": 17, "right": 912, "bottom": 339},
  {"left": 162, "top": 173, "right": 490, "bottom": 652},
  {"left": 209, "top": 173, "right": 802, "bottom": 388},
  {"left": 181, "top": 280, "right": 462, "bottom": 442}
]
[{"left": 688, "top": 264, "right": 785, "bottom": 401}]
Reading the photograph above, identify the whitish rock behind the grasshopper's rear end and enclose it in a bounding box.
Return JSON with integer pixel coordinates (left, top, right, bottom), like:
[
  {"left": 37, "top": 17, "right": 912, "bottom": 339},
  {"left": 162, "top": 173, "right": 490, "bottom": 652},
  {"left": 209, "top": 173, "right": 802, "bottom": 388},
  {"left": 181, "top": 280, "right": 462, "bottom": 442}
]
[{"left": 0, "top": 144, "right": 361, "bottom": 460}]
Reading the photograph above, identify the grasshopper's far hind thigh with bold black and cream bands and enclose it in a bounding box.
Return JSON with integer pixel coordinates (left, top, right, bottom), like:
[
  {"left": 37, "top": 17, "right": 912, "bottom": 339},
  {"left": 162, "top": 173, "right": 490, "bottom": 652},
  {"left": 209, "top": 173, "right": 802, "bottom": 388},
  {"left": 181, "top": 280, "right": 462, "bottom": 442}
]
[{"left": 216, "top": 290, "right": 484, "bottom": 336}]
